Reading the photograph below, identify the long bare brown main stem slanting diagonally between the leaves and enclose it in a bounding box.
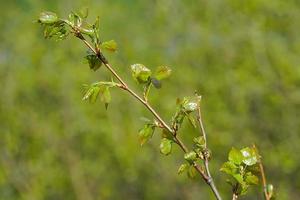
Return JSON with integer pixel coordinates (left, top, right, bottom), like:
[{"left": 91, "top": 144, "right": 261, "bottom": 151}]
[{"left": 75, "top": 33, "right": 222, "bottom": 200}]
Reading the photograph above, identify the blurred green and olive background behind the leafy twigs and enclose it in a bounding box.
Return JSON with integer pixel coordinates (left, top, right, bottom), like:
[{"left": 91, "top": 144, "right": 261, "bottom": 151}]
[{"left": 0, "top": 0, "right": 300, "bottom": 200}]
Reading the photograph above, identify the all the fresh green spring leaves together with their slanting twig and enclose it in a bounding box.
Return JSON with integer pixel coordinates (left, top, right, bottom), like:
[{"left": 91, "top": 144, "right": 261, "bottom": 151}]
[{"left": 38, "top": 8, "right": 274, "bottom": 199}]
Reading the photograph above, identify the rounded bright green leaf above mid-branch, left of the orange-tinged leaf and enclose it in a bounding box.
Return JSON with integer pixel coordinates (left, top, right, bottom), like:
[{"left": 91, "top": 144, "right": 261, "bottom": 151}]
[{"left": 130, "top": 64, "right": 151, "bottom": 83}]
